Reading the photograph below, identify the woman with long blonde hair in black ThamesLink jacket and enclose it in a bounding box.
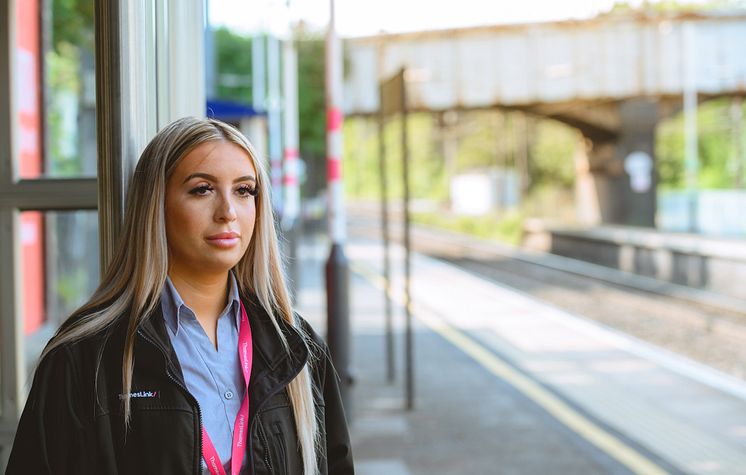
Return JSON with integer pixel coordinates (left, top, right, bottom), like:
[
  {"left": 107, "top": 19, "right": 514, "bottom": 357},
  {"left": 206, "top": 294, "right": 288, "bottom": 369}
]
[{"left": 7, "top": 118, "right": 353, "bottom": 475}]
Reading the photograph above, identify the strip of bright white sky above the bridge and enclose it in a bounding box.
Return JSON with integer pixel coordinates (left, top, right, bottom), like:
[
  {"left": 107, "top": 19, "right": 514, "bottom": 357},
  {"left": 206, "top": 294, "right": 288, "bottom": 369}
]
[{"left": 209, "top": 0, "right": 708, "bottom": 37}]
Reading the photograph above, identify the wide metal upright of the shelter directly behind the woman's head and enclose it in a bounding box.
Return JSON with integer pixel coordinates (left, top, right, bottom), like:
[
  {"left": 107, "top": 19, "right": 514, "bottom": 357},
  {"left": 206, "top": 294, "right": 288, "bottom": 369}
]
[{"left": 94, "top": 0, "right": 158, "bottom": 275}]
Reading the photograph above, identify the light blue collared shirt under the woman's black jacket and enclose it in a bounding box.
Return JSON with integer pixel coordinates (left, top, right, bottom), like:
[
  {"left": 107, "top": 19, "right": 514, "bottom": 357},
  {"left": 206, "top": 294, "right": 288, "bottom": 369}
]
[{"left": 161, "top": 272, "right": 248, "bottom": 474}]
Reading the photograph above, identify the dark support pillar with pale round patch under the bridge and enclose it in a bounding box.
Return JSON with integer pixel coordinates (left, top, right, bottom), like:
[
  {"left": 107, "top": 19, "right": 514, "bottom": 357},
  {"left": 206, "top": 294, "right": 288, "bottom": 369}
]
[{"left": 575, "top": 99, "right": 659, "bottom": 227}]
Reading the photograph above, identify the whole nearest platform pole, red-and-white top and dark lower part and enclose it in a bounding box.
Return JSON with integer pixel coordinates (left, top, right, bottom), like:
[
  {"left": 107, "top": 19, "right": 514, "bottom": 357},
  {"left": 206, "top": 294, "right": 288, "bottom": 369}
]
[{"left": 325, "top": 0, "right": 352, "bottom": 416}]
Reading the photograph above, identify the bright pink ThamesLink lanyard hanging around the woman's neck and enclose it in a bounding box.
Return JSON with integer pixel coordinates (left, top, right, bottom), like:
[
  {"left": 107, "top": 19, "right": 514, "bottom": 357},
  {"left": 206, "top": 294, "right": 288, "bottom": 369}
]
[{"left": 202, "top": 302, "right": 253, "bottom": 475}]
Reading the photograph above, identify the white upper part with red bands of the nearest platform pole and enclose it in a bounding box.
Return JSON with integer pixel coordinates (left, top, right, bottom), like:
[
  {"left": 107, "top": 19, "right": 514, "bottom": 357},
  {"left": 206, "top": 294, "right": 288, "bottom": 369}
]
[{"left": 326, "top": 0, "right": 346, "bottom": 244}]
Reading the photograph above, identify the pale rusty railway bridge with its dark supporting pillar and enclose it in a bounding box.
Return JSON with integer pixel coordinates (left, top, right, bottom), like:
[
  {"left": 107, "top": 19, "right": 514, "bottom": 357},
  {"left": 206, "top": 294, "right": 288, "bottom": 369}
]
[{"left": 345, "top": 14, "right": 746, "bottom": 226}]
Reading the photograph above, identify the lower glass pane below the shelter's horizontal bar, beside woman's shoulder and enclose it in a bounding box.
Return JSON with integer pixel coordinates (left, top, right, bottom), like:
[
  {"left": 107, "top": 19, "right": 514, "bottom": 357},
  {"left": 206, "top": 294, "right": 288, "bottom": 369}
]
[{"left": 20, "top": 211, "right": 99, "bottom": 375}]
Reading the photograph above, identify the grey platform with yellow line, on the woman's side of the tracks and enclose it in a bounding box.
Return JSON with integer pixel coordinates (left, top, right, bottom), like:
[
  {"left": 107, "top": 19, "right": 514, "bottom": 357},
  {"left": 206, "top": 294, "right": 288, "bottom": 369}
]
[{"left": 298, "top": 239, "right": 746, "bottom": 475}]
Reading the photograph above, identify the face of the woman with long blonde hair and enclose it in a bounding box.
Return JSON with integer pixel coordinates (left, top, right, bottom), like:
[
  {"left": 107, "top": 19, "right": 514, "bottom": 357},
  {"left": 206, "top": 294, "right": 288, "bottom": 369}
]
[{"left": 165, "top": 140, "right": 257, "bottom": 275}]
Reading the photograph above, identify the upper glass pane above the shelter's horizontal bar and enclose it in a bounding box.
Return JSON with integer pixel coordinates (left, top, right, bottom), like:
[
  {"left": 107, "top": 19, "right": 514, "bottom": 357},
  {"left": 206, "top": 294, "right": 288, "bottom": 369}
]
[{"left": 16, "top": 0, "right": 96, "bottom": 178}]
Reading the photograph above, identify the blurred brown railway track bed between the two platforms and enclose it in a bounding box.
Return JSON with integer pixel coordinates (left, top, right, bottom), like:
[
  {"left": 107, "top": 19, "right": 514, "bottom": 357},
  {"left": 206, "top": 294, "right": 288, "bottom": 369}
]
[{"left": 349, "top": 213, "right": 746, "bottom": 380}]
